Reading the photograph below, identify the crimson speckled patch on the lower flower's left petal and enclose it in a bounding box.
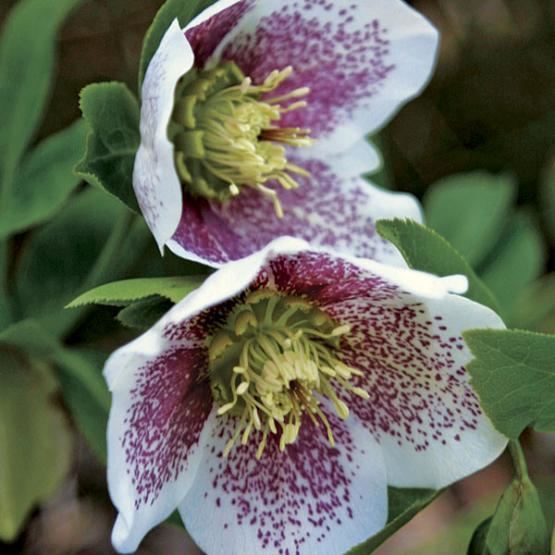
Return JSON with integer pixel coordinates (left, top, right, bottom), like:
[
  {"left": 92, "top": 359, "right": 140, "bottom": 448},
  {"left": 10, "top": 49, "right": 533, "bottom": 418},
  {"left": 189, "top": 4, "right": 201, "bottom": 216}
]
[{"left": 121, "top": 348, "right": 212, "bottom": 509}]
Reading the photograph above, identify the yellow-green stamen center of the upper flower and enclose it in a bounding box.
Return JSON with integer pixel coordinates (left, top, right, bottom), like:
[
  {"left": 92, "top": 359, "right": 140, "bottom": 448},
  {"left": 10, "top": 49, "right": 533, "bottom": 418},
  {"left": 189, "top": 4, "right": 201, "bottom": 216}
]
[{"left": 168, "top": 62, "right": 313, "bottom": 217}]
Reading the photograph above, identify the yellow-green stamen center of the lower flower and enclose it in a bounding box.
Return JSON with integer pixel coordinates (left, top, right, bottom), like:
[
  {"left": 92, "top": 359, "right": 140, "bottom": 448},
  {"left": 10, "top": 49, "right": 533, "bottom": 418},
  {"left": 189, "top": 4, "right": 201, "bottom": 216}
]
[{"left": 208, "top": 289, "right": 368, "bottom": 458}]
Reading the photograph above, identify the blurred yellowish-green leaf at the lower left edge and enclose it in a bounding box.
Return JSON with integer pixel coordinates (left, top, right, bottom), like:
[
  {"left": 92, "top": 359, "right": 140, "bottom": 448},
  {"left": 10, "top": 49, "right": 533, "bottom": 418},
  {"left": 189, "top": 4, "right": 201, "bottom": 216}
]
[{"left": 0, "top": 350, "right": 71, "bottom": 541}]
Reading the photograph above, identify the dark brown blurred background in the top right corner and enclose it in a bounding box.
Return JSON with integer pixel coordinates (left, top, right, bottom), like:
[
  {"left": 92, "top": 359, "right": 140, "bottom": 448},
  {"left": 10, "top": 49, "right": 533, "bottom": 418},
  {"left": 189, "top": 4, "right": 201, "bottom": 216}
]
[{"left": 398, "top": 0, "right": 555, "bottom": 201}]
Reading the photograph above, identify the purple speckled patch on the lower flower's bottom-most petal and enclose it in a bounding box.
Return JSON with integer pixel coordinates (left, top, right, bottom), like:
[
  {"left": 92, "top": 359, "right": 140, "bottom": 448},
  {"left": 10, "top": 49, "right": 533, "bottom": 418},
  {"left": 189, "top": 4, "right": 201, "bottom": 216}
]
[{"left": 191, "top": 414, "right": 370, "bottom": 555}]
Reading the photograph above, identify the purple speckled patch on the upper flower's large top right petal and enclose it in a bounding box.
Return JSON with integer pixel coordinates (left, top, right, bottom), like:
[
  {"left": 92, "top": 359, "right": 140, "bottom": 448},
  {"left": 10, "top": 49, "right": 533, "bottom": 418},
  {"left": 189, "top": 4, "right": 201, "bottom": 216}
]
[{"left": 222, "top": 0, "right": 395, "bottom": 137}]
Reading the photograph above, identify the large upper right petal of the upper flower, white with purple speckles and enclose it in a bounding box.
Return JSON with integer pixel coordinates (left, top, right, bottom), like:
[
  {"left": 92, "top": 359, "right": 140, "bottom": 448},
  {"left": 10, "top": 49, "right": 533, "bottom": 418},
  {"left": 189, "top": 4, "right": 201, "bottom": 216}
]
[{"left": 207, "top": 0, "right": 438, "bottom": 152}]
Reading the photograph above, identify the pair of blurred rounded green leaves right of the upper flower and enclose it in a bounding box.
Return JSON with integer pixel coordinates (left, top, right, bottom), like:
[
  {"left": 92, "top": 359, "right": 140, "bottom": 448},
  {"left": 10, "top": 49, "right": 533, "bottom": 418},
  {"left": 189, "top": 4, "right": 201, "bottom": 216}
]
[{"left": 424, "top": 172, "right": 546, "bottom": 325}]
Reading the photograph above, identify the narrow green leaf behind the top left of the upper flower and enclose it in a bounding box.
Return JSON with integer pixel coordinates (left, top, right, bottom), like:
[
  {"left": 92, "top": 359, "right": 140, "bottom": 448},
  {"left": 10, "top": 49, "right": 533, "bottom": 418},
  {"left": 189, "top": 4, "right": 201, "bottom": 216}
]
[{"left": 139, "top": 0, "right": 215, "bottom": 90}]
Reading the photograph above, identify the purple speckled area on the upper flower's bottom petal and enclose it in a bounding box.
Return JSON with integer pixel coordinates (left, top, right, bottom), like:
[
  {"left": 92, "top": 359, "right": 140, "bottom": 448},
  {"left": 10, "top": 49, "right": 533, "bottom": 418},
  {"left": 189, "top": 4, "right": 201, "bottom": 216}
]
[{"left": 173, "top": 160, "right": 402, "bottom": 262}]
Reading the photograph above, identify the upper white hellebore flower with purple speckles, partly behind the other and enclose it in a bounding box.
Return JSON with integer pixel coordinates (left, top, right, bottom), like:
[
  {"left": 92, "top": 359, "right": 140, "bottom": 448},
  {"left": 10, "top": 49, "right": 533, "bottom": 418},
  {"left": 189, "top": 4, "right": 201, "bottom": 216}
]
[{"left": 133, "top": 0, "right": 438, "bottom": 266}]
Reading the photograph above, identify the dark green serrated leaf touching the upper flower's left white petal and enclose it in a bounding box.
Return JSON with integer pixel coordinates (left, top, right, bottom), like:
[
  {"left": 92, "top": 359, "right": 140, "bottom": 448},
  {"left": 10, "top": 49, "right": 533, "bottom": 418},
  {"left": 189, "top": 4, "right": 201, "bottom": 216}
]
[{"left": 75, "top": 82, "right": 141, "bottom": 211}]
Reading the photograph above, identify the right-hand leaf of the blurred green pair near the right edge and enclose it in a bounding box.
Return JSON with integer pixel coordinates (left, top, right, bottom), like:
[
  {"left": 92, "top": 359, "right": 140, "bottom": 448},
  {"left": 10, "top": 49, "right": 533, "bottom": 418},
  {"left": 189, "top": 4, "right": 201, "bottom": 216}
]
[{"left": 482, "top": 212, "right": 546, "bottom": 316}]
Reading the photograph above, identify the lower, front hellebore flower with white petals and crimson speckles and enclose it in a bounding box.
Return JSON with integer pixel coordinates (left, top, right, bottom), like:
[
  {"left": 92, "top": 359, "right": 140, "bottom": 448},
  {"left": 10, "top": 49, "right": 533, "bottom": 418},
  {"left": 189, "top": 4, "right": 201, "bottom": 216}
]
[{"left": 105, "top": 237, "right": 506, "bottom": 555}]
